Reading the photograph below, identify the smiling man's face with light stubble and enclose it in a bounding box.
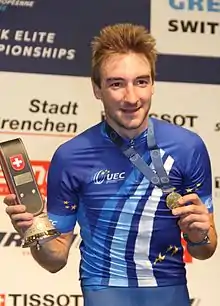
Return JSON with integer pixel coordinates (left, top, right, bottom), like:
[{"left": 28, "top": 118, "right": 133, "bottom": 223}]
[{"left": 93, "top": 53, "right": 153, "bottom": 135}]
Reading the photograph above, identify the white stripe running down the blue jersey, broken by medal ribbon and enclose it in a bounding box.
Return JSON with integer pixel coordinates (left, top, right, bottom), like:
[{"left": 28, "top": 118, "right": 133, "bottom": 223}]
[{"left": 134, "top": 154, "right": 174, "bottom": 286}]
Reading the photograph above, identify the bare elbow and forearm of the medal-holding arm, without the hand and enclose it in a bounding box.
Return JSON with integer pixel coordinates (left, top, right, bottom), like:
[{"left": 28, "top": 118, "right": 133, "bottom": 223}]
[{"left": 187, "top": 214, "right": 217, "bottom": 260}]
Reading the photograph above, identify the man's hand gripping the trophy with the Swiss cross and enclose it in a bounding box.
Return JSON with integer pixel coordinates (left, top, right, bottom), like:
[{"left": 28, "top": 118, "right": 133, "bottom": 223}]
[{"left": 4, "top": 194, "right": 33, "bottom": 236}]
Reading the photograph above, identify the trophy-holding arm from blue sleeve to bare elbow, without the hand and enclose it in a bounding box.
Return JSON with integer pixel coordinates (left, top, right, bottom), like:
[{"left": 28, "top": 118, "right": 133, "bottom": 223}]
[{"left": 31, "top": 145, "right": 79, "bottom": 273}]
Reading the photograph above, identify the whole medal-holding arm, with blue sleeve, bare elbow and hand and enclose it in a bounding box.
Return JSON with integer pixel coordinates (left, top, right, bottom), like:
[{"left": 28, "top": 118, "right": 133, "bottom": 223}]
[{"left": 178, "top": 134, "right": 217, "bottom": 260}]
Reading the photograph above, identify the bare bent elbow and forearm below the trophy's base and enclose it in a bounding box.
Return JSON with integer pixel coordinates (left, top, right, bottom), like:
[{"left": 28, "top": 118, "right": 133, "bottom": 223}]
[{"left": 31, "top": 232, "right": 73, "bottom": 273}]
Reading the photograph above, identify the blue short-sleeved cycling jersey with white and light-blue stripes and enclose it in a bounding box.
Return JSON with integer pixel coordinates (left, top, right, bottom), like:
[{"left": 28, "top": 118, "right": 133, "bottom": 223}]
[{"left": 47, "top": 119, "right": 213, "bottom": 288}]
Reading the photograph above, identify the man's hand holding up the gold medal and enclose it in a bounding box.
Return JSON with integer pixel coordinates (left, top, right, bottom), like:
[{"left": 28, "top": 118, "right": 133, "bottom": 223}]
[{"left": 172, "top": 193, "right": 211, "bottom": 242}]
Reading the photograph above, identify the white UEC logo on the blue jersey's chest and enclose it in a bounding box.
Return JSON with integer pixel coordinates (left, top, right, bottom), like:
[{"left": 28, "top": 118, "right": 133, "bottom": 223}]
[{"left": 93, "top": 169, "right": 125, "bottom": 185}]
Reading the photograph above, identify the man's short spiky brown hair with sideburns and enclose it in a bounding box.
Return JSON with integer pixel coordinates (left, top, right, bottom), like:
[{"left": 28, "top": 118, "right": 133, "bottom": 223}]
[{"left": 91, "top": 23, "right": 157, "bottom": 87}]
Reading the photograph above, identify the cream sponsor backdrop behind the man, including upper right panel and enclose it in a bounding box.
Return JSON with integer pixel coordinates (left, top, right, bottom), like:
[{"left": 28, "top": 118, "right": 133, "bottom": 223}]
[{"left": 0, "top": 0, "right": 220, "bottom": 306}]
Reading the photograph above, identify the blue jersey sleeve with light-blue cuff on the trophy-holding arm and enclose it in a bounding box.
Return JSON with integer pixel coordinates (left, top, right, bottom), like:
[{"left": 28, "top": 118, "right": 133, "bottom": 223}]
[{"left": 47, "top": 149, "right": 79, "bottom": 233}]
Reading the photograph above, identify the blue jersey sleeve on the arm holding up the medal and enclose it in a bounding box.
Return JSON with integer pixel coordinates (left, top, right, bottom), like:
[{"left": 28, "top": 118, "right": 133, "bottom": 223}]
[{"left": 184, "top": 135, "right": 213, "bottom": 213}]
